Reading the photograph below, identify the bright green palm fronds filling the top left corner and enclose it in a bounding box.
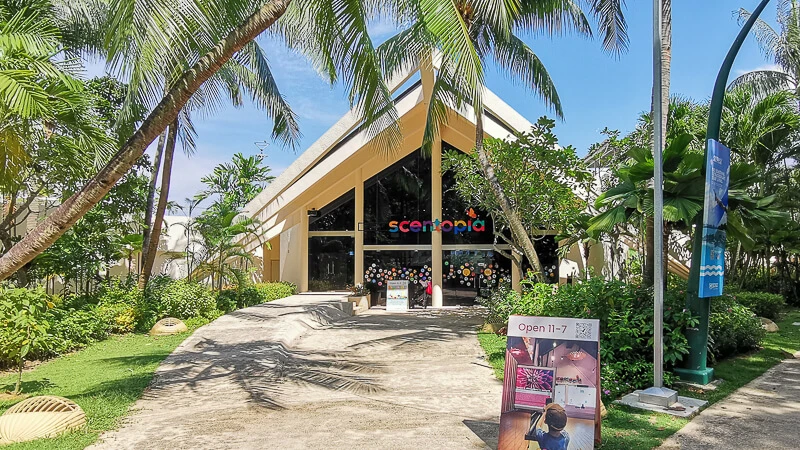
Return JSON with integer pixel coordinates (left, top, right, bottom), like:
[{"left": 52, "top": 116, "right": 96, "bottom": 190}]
[{"left": 0, "top": 2, "right": 110, "bottom": 190}]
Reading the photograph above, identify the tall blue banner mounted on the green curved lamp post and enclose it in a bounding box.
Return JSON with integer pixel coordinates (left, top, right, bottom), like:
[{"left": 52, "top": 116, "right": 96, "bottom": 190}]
[{"left": 699, "top": 139, "right": 731, "bottom": 297}]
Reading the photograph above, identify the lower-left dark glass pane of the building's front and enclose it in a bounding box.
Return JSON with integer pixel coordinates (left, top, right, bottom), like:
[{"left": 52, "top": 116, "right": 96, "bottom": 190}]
[{"left": 308, "top": 236, "right": 355, "bottom": 292}]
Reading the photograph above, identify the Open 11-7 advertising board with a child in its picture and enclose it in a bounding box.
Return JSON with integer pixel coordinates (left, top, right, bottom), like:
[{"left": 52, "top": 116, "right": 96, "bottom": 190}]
[{"left": 498, "top": 316, "right": 600, "bottom": 450}]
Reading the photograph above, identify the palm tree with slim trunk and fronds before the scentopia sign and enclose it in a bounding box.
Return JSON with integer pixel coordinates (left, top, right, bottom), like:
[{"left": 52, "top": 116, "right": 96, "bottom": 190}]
[{"left": 378, "top": 0, "right": 627, "bottom": 280}]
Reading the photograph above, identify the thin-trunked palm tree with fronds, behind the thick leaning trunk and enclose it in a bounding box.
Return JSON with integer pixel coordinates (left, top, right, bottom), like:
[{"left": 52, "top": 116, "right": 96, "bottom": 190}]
[{"left": 107, "top": 0, "right": 299, "bottom": 288}]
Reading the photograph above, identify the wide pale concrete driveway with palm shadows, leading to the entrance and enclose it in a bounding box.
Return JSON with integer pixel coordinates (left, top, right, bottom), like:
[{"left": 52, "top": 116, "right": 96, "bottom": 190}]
[{"left": 91, "top": 295, "right": 502, "bottom": 450}]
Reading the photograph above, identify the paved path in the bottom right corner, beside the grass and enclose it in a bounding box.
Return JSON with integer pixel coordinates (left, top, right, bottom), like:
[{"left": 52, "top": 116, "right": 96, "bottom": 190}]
[{"left": 660, "top": 359, "right": 800, "bottom": 450}]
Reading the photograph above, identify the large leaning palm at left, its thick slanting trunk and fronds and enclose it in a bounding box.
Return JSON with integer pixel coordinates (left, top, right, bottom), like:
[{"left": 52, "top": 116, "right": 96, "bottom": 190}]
[{"left": 0, "top": 0, "right": 399, "bottom": 280}]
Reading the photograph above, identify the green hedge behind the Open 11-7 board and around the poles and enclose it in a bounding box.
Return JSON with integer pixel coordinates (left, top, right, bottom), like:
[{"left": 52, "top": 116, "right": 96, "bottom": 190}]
[{"left": 484, "top": 278, "right": 764, "bottom": 400}]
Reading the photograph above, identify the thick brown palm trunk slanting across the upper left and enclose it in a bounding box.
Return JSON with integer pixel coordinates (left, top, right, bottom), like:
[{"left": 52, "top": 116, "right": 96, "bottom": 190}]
[{"left": 0, "top": 0, "right": 291, "bottom": 280}]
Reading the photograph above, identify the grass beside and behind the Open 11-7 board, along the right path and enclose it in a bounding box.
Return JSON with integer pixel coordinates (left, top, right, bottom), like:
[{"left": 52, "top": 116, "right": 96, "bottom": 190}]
[{"left": 478, "top": 309, "right": 800, "bottom": 450}]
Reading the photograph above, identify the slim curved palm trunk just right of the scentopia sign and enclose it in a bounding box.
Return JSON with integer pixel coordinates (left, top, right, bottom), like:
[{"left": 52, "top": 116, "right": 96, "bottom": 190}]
[{"left": 475, "top": 107, "right": 544, "bottom": 280}]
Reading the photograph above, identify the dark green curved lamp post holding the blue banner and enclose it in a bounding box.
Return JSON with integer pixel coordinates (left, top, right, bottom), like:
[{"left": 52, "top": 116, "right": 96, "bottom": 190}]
[{"left": 675, "top": 0, "right": 769, "bottom": 384}]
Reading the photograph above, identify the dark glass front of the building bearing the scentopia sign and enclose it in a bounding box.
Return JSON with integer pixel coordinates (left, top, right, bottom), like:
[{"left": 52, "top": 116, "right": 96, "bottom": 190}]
[{"left": 308, "top": 143, "right": 559, "bottom": 298}]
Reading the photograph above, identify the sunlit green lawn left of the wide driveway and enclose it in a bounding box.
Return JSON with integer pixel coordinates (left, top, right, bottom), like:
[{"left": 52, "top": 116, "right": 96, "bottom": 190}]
[{"left": 0, "top": 330, "right": 192, "bottom": 450}]
